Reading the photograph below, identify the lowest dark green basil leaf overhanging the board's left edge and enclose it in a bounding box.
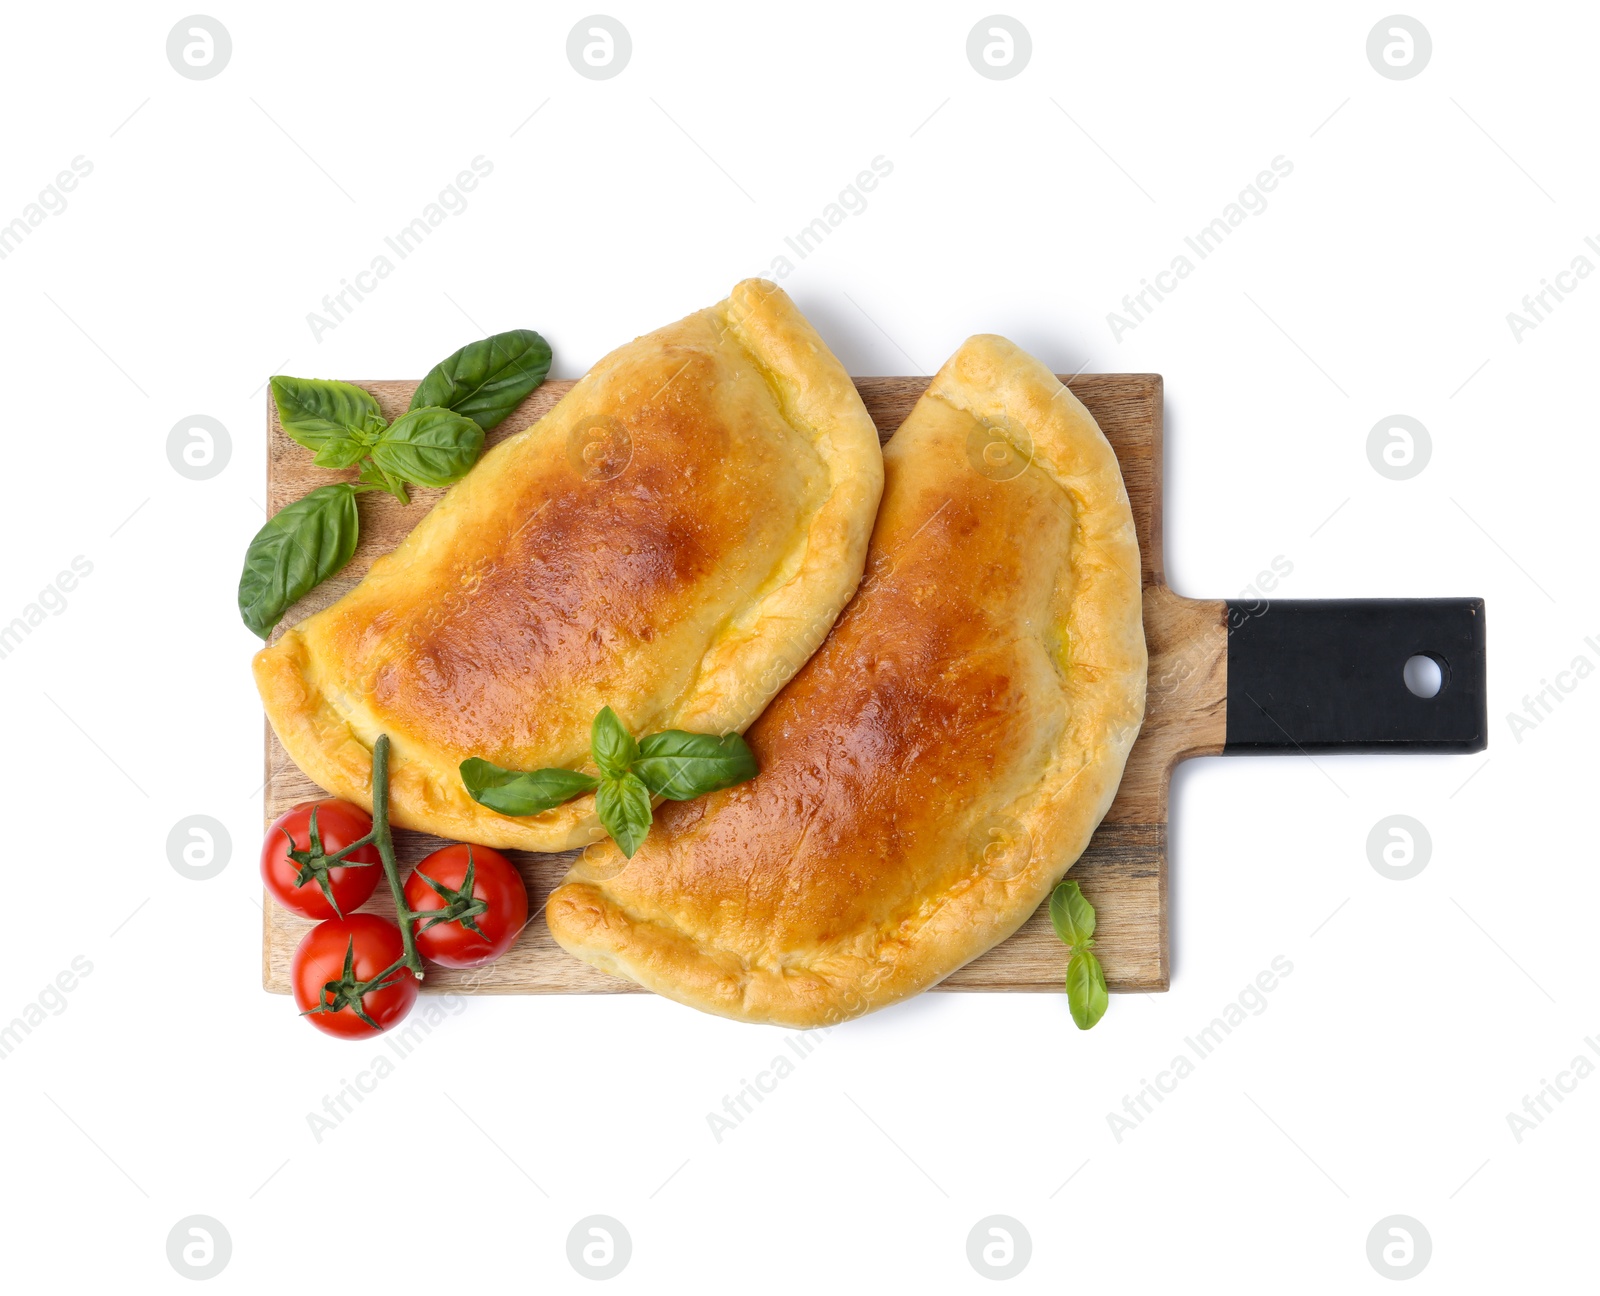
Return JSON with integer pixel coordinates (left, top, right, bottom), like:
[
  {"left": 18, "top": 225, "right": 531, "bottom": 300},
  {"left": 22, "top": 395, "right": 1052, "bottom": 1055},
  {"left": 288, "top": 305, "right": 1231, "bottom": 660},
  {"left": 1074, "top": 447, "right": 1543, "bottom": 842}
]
[{"left": 238, "top": 482, "right": 362, "bottom": 638}]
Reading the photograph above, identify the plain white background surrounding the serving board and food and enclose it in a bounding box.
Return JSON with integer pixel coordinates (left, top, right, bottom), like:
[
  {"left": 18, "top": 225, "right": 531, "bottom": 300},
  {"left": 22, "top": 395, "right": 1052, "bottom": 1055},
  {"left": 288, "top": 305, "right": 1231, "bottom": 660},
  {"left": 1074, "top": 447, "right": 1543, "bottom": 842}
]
[{"left": 0, "top": 0, "right": 1600, "bottom": 1293}]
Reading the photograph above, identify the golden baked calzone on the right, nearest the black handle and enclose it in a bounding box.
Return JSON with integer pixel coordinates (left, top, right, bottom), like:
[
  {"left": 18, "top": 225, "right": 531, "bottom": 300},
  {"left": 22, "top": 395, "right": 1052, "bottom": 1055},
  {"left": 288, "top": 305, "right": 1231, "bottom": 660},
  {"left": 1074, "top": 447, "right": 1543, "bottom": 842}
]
[{"left": 546, "top": 336, "right": 1147, "bottom": 1026}]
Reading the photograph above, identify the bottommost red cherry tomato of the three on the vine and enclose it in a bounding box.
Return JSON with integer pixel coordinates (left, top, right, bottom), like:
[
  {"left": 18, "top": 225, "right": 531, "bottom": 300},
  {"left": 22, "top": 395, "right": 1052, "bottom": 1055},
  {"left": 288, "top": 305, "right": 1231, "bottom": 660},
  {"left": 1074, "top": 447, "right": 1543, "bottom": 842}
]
[{"left": 290, "top": 914, "right": 421, "bottom": 1040}]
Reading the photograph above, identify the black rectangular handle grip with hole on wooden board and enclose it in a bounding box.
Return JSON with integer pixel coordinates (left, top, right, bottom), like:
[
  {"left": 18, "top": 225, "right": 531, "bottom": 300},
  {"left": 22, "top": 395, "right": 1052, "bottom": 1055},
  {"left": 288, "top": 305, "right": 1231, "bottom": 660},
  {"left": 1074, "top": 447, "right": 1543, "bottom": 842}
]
[{"left": 1222, "top": 598, "right": 1488, "bottom": 754}]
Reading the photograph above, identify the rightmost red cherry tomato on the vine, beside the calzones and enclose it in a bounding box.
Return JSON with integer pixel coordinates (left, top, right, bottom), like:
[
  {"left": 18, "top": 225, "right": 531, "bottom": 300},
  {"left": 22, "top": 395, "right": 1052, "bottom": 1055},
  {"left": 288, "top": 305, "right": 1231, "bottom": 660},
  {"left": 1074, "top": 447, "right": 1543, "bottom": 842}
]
[{"left": 405, "top": 845, "right": 528, "bottom": 968}]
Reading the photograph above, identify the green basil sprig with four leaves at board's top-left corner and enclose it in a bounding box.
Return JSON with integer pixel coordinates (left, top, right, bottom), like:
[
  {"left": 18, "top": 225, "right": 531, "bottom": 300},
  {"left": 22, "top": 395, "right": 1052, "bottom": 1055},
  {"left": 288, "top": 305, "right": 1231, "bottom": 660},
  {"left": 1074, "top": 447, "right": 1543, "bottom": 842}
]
[{"left": 238, "top": 328, "right": 550, "bottom": 640}]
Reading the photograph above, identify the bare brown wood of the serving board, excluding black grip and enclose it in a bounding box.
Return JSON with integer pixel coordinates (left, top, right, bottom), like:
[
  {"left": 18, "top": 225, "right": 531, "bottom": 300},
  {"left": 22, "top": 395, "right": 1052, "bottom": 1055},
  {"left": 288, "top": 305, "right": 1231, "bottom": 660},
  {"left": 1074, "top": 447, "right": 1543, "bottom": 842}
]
[{"left": 261, "top": 374, "right": 1227, "bottom": 994}]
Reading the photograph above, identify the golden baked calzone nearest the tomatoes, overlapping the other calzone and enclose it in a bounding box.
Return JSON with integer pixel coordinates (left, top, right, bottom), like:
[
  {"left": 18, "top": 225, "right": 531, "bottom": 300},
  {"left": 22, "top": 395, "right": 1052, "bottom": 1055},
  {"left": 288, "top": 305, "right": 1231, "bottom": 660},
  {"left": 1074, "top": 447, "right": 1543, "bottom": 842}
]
[{"left": 254, "top": 280, "right": 883, "bottom": 851}]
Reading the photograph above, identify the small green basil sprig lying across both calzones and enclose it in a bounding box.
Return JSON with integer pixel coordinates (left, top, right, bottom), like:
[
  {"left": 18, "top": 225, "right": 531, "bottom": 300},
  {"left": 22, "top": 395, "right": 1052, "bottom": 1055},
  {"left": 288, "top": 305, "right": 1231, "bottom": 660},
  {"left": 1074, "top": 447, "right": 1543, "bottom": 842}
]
[{"left": 461, "top": 707, "right": 758, "bottom": 859}]
